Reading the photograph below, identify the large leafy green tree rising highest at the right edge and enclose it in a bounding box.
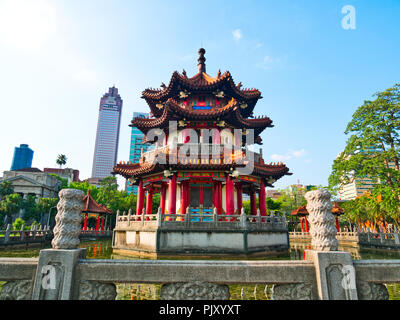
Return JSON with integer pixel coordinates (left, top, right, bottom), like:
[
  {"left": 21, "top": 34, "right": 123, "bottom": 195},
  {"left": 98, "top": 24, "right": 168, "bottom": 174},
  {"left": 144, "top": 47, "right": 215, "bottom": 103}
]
[{"left": 329, "top": 84, "right": 400, "bottom": 190}]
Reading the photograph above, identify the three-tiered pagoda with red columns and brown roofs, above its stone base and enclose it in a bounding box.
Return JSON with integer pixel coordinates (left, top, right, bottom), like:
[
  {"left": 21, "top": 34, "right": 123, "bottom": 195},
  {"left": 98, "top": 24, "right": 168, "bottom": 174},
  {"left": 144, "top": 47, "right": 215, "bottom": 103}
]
[{"left": 114, "top": 49, "right": 290, "bottom": 258}]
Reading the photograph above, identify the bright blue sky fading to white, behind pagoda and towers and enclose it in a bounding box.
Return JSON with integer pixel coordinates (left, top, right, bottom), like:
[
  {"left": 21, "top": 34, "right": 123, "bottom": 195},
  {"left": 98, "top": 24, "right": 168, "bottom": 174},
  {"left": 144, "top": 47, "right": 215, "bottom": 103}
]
[{"left": 0, "top": 0, "right": 400, "bottom": 188}]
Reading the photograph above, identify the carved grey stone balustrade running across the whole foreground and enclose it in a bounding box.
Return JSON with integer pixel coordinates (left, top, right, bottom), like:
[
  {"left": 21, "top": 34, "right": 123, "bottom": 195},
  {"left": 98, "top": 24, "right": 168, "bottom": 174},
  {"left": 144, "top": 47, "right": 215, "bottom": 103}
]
[{"left": 0, "top": 190, "right": 400, "bottom": 300}]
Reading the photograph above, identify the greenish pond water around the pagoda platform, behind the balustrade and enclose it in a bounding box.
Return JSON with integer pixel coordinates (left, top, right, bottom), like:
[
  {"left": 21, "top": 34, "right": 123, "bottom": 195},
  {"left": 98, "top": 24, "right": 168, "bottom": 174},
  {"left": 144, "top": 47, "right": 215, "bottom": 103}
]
[{"left": 0, "top": 240, "right": 400, "bottom": 300}]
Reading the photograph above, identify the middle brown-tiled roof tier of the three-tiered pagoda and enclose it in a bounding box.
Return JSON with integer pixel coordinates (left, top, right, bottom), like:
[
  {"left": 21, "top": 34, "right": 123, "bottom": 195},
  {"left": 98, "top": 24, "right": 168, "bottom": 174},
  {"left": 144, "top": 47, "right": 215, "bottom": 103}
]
[{"left": 130, "top": 98, "right": 273, "bottom": 136}]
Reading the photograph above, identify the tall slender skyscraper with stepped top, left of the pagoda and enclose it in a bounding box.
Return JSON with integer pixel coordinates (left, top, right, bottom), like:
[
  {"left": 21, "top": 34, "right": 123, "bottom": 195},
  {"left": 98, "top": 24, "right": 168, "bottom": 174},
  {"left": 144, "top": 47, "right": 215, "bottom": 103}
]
[{"left": 91, "top": 87, "right": 122, "bottom": 184}]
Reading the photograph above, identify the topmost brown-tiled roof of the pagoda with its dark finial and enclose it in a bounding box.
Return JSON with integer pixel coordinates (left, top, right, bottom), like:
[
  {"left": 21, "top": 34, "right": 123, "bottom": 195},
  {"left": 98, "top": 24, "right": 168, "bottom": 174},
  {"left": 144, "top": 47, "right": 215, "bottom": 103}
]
[{"left": 142, "top": 48, "right": 262, "bottom": 118}]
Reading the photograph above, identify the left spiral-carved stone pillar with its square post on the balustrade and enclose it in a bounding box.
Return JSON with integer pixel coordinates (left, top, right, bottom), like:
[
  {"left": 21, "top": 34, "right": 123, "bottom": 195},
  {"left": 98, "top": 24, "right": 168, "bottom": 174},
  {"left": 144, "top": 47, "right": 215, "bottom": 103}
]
[{"left": 32, "top": 189, "right": 116, "bottom": 300}]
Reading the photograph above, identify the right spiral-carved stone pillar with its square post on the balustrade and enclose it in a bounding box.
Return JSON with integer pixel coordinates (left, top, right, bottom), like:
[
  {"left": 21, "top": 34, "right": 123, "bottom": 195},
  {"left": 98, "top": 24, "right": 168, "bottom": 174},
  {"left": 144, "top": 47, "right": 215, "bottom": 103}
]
[{"left": 305, "top": 190, "right": 358, "bottom": 300}]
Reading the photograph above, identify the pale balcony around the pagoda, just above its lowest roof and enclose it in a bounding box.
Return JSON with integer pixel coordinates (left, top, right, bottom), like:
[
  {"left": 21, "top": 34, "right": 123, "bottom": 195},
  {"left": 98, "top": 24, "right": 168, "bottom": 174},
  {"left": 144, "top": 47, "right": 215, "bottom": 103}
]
[{"left": 139, "top": 143, "right": 262, "bottom": 165}]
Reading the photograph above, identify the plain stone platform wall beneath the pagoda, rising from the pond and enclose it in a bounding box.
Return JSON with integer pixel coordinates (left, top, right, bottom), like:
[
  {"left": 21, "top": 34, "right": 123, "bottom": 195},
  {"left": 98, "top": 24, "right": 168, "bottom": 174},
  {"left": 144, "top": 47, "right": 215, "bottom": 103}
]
[{"left": 113, "top": 228, "right": 289, "bottom": 259}]
